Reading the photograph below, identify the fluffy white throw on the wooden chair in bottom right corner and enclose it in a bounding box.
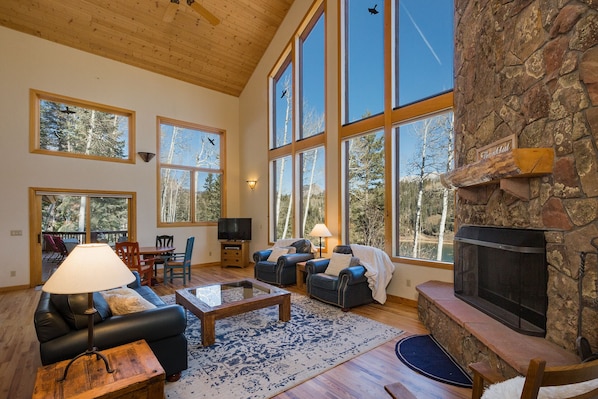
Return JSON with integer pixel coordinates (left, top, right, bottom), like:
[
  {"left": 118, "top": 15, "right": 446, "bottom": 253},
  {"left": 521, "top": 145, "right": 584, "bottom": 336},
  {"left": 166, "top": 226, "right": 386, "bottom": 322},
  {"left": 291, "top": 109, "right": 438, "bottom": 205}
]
[{"left": 482, "top": 377, "right": 598, "bottom": 399}]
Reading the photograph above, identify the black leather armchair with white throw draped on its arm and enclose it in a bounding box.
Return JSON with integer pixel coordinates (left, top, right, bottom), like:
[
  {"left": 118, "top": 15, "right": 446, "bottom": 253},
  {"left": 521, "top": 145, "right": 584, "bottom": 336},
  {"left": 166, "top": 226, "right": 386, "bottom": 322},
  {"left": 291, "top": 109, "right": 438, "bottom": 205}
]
[{"left": 305, "top": 245, "right": 374, "bottom": 312}]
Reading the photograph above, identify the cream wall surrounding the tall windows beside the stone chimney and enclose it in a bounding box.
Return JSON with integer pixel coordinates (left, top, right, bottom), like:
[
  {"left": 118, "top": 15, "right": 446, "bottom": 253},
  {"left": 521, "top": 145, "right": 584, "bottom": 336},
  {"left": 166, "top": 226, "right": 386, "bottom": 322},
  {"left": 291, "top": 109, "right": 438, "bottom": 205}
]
[{"left": 240, "top": 1, "right": 453, "bottom": 300}]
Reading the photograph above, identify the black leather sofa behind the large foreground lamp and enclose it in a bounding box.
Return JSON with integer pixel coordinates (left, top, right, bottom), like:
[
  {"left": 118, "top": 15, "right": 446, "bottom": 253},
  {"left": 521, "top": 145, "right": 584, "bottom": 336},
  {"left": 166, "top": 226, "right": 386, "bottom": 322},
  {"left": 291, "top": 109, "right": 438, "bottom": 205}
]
[{"left": 34, "top": 274, "right": 187, "bottom": 381}]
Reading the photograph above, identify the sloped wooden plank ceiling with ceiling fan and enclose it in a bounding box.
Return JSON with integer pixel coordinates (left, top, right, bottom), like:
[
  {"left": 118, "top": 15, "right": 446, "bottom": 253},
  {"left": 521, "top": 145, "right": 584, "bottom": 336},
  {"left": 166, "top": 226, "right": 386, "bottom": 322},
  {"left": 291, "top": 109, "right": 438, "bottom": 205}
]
[{"left": 0, "top": 0, "right": 293, "bottom": 96}]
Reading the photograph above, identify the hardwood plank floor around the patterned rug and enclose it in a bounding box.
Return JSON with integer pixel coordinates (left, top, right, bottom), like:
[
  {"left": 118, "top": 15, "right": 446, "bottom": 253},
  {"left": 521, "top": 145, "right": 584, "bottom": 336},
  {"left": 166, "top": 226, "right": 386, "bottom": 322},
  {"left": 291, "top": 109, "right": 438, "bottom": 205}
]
[{"left": 0, "top": 266, "right": 471, "bottom": 399}]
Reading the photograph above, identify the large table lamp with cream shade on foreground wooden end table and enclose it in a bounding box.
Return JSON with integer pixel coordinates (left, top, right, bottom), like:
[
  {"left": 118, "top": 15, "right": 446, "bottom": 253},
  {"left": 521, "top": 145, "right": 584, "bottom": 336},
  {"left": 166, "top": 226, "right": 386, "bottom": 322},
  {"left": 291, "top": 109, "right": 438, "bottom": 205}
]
[{"left": 42, "top": 244, "right": 135, "bottom": 381}]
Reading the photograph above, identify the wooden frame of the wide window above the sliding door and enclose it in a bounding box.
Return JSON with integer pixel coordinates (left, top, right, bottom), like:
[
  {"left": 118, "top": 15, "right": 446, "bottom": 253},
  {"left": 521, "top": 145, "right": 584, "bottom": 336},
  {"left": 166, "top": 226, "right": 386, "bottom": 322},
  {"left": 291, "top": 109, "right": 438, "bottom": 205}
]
[{"left": 29, "top": 89, "right": 136, "bottom": 164}]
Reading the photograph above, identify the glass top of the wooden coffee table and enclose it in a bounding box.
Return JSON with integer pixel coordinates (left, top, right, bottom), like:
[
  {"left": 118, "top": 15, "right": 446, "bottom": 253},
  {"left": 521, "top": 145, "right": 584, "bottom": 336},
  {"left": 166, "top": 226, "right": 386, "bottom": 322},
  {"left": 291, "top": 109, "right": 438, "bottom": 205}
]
[{"left": 187, "top": 280, "right": 277, "bottom": 307}]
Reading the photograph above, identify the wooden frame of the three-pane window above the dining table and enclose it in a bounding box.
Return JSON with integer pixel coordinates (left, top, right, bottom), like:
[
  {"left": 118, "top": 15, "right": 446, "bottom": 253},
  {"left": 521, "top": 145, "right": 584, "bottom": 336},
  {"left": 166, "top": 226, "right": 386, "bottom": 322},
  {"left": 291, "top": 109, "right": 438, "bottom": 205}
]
[{"left": 156, "top": 116, "right": 226, "bottom": 227}]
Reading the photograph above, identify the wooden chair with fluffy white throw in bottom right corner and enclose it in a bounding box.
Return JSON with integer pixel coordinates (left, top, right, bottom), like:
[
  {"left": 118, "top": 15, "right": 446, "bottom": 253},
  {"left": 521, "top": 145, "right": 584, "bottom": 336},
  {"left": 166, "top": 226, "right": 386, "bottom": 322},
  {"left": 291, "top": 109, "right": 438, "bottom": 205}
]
[{"left": 469, "top": 359, "right": 598, "bottom": 399}]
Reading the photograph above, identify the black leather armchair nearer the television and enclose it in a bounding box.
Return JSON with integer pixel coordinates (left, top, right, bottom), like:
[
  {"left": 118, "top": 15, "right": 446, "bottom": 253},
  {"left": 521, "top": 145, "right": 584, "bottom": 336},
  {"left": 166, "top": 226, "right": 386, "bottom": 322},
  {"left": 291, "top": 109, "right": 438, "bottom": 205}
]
[{"left": 253, "top": 239, "right": 314, "bottom": 286}]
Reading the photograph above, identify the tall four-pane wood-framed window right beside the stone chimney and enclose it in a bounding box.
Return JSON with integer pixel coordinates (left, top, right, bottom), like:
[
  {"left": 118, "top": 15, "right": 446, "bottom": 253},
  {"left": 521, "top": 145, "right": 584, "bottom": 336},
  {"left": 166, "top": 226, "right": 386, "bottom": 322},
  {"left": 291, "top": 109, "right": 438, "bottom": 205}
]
[{"left": 340, "top": 0, "right": 454, "bottom": 263}]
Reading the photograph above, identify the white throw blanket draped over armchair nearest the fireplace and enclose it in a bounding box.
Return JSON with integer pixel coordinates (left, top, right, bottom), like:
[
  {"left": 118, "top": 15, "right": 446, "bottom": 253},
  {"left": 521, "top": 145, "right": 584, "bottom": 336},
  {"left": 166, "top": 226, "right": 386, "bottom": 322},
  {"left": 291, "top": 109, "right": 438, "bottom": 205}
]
[{"left": 351, "top": 244, "right": 395, "bottom": 304}]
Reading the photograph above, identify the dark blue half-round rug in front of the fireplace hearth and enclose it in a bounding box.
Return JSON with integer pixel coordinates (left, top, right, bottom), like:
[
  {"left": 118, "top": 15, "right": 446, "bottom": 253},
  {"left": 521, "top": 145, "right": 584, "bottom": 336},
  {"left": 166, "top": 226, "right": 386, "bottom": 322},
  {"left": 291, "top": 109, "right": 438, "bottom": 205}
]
[{"left": 395, "top": 335, "right": 472, "bottom": 388}]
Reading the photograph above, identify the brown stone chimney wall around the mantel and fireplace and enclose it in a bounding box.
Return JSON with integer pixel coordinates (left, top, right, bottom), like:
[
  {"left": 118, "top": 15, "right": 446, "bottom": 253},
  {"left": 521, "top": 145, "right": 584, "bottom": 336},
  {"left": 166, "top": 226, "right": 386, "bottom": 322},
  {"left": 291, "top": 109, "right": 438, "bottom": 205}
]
[{"left": 454, "top": 0, "right": 598, "bottom": 351}]
